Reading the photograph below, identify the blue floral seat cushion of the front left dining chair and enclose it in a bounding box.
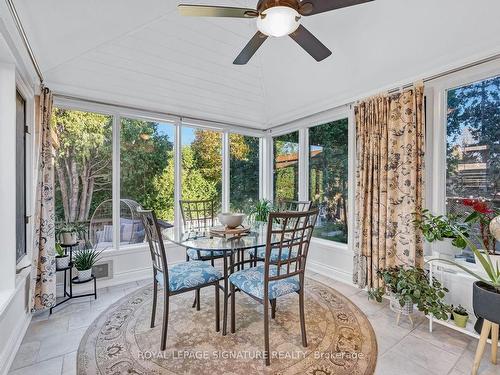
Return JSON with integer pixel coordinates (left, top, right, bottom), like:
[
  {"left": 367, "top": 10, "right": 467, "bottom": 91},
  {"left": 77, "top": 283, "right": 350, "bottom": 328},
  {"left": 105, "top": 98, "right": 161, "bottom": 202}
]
[{"left": 156, "top": 260, "right": 222, "bottom": 292}]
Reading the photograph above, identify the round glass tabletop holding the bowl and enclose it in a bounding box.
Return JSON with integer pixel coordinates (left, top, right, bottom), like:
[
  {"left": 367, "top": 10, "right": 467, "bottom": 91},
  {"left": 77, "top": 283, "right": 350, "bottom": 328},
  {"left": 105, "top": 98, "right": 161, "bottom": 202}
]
[{"left": 162, "top": 222, "right": 274, "bottom": 251}]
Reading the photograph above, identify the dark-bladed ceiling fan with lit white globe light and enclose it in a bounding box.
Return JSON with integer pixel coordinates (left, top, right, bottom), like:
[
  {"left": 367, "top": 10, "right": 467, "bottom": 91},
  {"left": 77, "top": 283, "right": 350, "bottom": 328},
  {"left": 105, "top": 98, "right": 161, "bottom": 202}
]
[{"left": 178, "top": 0, "right": 374, "bottom": 65}]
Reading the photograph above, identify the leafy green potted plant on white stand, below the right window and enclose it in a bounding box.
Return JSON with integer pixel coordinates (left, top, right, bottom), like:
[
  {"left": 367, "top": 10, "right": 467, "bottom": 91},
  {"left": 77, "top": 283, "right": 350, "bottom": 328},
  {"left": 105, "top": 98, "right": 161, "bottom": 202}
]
[{"left": 414, "top": 210, "right": 469, "bottom": 249}]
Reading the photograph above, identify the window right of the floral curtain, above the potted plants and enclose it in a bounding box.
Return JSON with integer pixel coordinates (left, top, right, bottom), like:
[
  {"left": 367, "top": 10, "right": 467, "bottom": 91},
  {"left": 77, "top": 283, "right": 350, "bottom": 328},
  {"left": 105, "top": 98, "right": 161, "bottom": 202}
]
[{"left": 446, "top": 76, "right": 500, "bottom": 214}]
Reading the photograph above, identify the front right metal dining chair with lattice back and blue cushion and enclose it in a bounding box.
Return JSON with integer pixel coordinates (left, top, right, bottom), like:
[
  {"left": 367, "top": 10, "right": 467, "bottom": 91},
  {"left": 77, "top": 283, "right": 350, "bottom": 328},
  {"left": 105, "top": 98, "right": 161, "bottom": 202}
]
[{"left": 224, "top": 209, "right": 318, "bottom": 366}]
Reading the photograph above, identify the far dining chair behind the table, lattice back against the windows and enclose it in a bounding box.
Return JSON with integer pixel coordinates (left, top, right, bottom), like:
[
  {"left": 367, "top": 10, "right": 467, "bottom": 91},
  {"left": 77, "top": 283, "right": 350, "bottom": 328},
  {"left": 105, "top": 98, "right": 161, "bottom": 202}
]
[{"left": 179, "top": 199, "right": 225, "bottom": 311}]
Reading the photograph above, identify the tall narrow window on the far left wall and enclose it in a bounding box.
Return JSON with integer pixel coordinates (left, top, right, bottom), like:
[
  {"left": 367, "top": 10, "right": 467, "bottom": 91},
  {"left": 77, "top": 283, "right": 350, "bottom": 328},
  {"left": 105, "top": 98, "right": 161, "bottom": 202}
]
[{"left": 16, "top": 92, "right": 26, "bottom": 262}]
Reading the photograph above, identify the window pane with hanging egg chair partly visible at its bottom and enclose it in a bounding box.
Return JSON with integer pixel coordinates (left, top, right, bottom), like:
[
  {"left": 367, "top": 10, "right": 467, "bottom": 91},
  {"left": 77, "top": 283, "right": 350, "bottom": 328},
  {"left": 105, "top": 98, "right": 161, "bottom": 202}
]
[{"left": 120, "top": 118, "right": 175, "bottom": 245}]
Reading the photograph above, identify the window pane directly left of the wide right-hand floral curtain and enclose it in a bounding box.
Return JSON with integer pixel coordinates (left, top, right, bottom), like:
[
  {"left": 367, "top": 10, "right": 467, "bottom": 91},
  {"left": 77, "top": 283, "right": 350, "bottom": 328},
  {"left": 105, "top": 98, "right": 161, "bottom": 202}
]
[{"left": 309, "top": 119, "right": 348, "bottom": 243}]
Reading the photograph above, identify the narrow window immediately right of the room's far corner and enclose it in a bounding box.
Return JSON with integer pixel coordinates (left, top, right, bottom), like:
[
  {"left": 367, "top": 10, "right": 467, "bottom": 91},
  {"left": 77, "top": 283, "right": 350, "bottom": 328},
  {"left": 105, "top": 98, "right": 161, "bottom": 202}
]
[{"left": 273, "top": 131, "right": 299, "bottom": 202}]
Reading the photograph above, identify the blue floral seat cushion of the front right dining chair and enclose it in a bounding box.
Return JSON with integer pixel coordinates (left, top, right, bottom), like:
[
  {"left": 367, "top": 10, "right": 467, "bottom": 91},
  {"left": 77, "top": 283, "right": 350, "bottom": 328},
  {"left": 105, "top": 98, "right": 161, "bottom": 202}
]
[{"left": 229, "top": 264, "right": 300, "bottom": 299}]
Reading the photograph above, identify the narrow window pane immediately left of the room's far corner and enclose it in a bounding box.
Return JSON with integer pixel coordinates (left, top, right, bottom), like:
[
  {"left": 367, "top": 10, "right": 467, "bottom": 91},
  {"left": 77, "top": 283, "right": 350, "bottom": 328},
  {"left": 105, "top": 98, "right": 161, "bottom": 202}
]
[{"left": 229, "top": 134, "right": 259, "bottom": 214}]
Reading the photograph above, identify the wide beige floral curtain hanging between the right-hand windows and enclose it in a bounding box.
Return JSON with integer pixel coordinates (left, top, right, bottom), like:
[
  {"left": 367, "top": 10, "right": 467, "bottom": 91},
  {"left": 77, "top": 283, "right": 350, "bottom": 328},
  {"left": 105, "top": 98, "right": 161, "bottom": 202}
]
[{"left": 353, "top": 83, "right": 425, "bottom": 288}]
